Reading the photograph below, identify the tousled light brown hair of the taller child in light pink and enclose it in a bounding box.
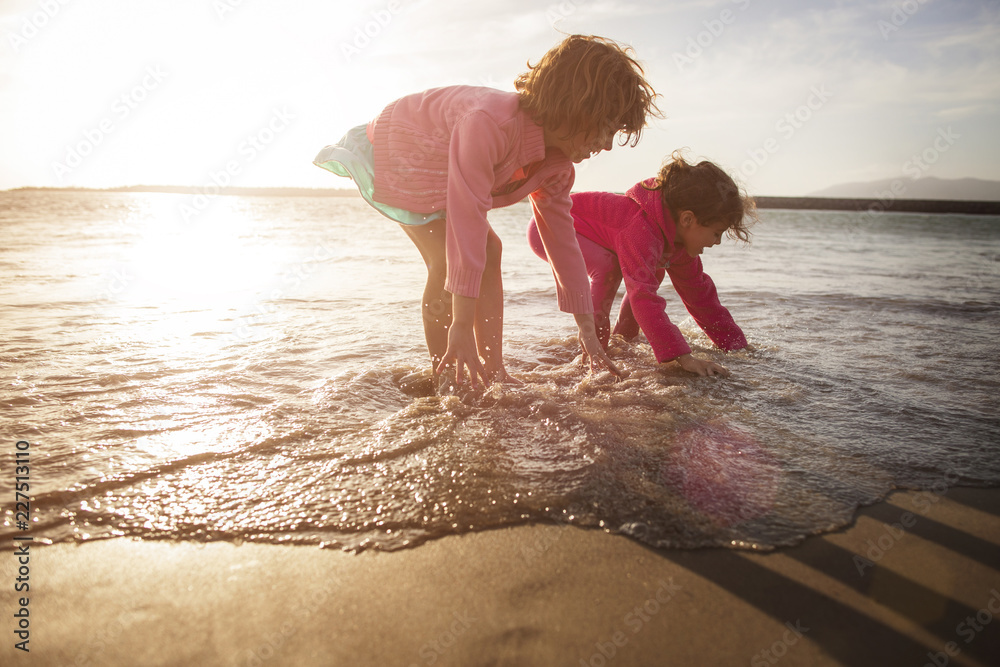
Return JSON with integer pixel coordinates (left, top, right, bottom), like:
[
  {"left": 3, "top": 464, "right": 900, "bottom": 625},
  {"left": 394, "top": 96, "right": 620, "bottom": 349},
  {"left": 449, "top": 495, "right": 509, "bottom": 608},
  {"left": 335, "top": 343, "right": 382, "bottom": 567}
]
[{"left": 514, "top": 35, "right": 660, "bottom": 146}]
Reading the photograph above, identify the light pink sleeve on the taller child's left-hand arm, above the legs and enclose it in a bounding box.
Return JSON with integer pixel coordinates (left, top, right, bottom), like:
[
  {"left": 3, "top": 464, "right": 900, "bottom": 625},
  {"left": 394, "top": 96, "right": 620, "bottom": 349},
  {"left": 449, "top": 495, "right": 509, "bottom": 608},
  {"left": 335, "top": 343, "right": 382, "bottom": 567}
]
[{"left": 445, "top": 111, "right": 506, "bottom": 298}]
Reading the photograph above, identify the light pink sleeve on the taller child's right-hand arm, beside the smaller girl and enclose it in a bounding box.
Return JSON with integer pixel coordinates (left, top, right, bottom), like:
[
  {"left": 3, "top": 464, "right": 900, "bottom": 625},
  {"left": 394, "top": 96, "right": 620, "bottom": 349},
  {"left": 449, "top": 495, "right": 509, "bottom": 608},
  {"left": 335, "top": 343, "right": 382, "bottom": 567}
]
[{"left": 531, "top": 167, "right": 594, "bottom": 314}]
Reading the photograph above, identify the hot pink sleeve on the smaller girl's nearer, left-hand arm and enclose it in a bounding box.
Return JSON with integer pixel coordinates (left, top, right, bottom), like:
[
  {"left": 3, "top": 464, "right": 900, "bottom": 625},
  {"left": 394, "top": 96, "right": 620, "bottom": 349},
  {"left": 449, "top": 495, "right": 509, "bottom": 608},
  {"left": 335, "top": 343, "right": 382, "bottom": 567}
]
[{"left": 618, "top": 225, "right": 691, "bottom": 363}]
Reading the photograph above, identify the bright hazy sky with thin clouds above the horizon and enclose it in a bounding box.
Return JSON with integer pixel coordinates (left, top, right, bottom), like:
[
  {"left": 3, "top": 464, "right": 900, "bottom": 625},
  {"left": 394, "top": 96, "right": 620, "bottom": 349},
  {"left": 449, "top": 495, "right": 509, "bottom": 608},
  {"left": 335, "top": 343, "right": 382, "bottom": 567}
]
[{"left": 0, "top": 0, "right": 1000, "bottom": 196}]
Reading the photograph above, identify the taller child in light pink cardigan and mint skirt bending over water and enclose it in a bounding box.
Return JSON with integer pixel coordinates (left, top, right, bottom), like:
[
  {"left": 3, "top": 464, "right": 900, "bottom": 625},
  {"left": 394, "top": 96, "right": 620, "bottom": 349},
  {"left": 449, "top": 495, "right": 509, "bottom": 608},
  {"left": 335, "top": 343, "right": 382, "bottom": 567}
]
[{"left": 314, "top": 35, "right": 656, "bottom": 386}]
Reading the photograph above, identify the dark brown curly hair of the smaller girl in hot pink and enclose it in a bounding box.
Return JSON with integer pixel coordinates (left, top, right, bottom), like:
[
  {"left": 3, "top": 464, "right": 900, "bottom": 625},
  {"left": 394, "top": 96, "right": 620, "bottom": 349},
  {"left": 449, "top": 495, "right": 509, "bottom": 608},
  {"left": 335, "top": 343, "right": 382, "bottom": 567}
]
[{"left": 643, "top": 151, "right": 758, "bottom": 243}]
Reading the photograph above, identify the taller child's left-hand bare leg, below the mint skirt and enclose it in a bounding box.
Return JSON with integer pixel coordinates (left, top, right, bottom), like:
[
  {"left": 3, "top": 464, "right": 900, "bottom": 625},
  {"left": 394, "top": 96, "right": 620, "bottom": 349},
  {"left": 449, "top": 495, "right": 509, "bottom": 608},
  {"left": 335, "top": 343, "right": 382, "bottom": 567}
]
[{"left": 400, "top": 220, "right": 452, "bottom": 368}]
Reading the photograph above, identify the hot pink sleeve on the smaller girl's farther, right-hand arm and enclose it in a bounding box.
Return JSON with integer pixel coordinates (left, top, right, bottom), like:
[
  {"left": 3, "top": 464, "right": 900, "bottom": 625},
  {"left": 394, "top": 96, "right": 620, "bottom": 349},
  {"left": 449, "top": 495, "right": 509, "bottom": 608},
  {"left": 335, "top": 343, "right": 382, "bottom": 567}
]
[{"left": 667, "top": 257, "right": 747, "bottom": 351}]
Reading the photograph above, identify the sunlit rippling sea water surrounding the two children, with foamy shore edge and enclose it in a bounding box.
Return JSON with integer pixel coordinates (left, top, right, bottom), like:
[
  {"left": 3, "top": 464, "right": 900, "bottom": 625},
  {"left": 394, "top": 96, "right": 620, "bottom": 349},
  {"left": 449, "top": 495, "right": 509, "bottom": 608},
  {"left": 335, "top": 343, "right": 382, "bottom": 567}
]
[{"left": 0, "top": 191, "right": 1000, "bottom": 550}]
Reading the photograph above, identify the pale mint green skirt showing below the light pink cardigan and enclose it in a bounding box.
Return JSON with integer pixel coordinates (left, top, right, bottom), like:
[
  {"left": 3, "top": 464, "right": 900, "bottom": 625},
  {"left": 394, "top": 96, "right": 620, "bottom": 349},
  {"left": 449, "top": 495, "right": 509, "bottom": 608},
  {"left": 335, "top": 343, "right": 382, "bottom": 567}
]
[{"left": 313, "top": 125, "right": 444, "bottom": 225}]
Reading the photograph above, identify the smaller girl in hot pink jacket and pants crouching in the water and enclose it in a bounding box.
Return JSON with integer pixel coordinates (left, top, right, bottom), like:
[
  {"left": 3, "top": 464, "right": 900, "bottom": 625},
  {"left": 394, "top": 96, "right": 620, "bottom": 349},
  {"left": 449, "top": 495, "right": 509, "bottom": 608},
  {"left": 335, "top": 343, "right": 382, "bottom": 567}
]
[{"left": 528, "top": 152, "right": 756, "bottom": 375}]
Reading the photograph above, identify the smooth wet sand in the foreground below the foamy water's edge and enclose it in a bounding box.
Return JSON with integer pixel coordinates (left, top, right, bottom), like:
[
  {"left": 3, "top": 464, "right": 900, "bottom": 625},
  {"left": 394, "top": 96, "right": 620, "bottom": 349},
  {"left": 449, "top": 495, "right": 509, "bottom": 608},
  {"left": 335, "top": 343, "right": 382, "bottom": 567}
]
[{"left": 2, "top": 488, "right": 1000, "bottom": 667}]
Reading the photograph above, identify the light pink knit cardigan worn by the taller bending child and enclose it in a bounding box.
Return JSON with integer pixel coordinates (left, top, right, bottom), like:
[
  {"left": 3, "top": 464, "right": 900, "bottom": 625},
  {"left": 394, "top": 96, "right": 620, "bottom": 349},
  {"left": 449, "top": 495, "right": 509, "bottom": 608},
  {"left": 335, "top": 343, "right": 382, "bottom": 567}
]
[{"left": 370, "top": 86, "right": 593, "bottom": 313}]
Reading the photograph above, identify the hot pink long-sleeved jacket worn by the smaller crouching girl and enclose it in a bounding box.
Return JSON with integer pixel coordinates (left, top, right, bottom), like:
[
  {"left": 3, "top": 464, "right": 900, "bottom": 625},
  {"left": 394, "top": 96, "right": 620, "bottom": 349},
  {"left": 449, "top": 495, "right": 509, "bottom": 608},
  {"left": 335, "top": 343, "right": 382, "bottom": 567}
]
[{"left": 573, "top": 179, "right": 747, "bottom": 362}]
